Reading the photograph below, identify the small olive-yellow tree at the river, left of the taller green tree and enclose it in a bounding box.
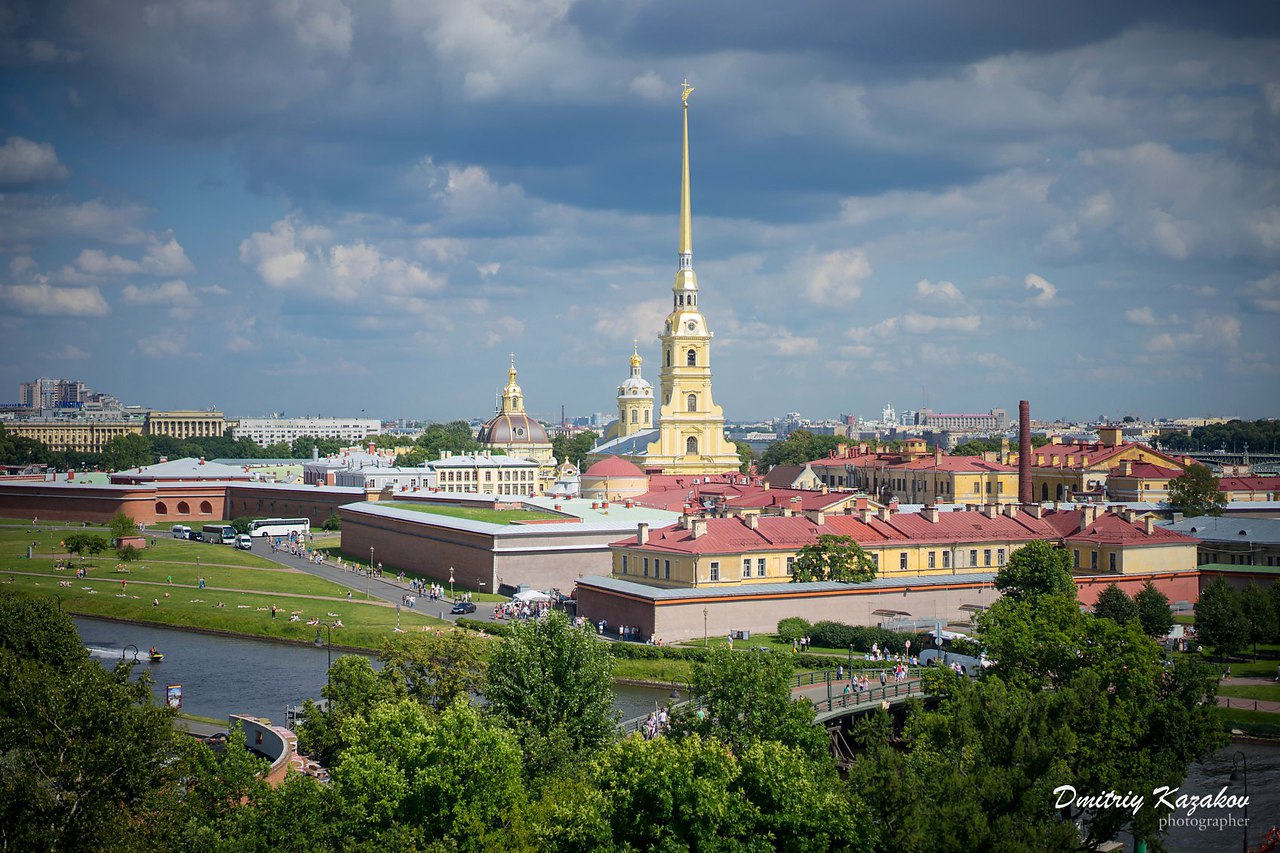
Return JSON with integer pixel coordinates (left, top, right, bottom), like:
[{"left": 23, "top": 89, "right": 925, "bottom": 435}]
[{"left": 379, "top": 629, "right": 485, "bottom": 711}]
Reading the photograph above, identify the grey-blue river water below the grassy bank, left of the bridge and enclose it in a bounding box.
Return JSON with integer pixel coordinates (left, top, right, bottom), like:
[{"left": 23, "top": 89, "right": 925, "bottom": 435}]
[{"left": 76, "top": 616, "right": 668, "bottom": 721}]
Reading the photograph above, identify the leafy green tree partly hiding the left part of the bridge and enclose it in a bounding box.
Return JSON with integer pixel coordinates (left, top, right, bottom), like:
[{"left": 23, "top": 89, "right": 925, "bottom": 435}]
[{"left": 672, "top": 647, "right": 829, "bottom": 760}]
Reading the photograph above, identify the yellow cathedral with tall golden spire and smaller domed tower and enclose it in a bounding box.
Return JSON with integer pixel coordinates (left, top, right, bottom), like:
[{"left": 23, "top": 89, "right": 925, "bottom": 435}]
[{"left": 591, "top": 83, "right": 740, "bottom": 474}]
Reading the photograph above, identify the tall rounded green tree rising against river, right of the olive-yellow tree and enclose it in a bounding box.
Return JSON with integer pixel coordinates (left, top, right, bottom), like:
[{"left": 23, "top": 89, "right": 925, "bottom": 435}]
[{"left": 483, "top": 611, "right": 617, "bottom": 774}]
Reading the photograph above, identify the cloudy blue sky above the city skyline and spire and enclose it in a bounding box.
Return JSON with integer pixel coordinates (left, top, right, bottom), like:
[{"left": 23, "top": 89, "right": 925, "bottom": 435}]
[{"left": 0, "top": 0, "right": 1280, "bottom": 420}]
